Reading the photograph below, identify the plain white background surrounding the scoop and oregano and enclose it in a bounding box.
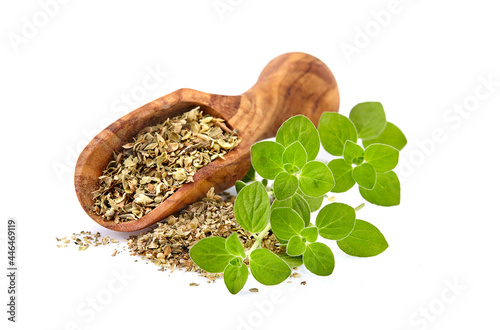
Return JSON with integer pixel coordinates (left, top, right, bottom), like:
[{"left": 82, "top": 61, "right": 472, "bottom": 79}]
[{"left": 0, "top": 0, "right": 500, "bottom": 330}]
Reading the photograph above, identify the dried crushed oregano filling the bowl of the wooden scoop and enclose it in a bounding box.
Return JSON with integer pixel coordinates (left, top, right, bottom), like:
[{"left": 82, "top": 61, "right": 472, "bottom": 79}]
[{"left": 93, "top": 107, "right": 239, "bottom": 222}]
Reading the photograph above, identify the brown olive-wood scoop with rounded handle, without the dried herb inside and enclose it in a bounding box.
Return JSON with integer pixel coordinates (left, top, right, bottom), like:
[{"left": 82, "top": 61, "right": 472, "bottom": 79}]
[{"left": 75, "top": 53, "right": 339, "bottom": 232}]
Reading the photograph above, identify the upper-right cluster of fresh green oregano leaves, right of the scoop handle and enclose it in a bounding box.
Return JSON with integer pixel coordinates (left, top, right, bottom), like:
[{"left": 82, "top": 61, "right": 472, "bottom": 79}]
[{"left": 318, "top": 102, "right": 406, "bottom": 206}]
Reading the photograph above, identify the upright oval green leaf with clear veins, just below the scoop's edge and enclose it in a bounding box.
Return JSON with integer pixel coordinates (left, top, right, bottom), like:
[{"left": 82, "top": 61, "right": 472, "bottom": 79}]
[{"left": 234, "top": 181, "right": 271, "bottom": 233}]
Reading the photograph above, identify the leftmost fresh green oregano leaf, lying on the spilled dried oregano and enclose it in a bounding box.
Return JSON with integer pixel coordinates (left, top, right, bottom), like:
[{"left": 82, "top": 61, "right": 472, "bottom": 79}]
[{"left": 189, "top": 236, "right": 234, "bottom": 273}]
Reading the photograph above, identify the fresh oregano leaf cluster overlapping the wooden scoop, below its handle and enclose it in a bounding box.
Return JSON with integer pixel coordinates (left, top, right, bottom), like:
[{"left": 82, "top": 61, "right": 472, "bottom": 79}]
[{"left": 251, "top": 115, "right": 335, "bottom": 200}]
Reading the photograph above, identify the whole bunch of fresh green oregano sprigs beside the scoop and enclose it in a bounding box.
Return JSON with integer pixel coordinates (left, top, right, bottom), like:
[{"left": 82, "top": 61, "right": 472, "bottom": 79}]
[{"left": 190, "top": 102, "right": 406, "bottom": 294}]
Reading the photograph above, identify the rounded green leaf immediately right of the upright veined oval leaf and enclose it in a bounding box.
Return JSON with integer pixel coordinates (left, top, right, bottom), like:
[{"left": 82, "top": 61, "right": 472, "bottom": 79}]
[{"left": 271, "top": 207, "right": 305, "bottom": 241}]
